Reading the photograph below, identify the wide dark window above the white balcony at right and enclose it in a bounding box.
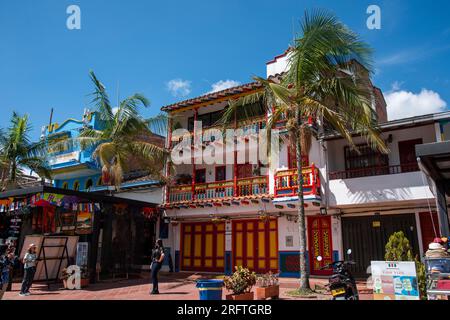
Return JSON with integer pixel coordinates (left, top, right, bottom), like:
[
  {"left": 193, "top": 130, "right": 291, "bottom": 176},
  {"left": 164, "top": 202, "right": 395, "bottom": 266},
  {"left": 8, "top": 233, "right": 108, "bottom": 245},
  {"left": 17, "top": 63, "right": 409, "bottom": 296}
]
[{"left": 344, "top": 145, "right": 389, "bottom": 178}]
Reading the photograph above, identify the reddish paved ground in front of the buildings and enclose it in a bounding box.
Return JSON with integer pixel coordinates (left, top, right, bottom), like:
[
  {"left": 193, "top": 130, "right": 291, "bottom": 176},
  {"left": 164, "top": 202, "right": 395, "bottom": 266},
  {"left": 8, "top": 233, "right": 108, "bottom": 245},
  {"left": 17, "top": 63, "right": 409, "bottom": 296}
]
[{"left": 3, "top": 273, "right": 372, "bottom": 300}]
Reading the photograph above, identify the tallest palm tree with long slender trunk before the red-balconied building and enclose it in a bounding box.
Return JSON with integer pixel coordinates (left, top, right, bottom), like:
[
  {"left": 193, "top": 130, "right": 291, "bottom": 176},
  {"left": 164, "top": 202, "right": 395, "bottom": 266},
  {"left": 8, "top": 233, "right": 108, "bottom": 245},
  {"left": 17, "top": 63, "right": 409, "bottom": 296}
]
[{"left": 222, "top": 11, "right": 387, "bottom": 292}]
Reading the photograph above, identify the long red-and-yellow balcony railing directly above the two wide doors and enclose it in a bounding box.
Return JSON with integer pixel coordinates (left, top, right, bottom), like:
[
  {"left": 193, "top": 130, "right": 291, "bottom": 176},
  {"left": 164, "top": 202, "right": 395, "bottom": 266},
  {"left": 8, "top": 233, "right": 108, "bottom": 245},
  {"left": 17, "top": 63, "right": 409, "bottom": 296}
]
[{"left": 168, "top": 176, "right": 269, "bottom": 203}]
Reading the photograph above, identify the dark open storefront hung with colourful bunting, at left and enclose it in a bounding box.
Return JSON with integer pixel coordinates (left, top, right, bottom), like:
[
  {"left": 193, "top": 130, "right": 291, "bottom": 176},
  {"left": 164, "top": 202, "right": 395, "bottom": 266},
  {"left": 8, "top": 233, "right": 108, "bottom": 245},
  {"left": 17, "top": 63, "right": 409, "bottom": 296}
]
[{"left": 0, "top": 186, "right": 159, "bottom": 280}]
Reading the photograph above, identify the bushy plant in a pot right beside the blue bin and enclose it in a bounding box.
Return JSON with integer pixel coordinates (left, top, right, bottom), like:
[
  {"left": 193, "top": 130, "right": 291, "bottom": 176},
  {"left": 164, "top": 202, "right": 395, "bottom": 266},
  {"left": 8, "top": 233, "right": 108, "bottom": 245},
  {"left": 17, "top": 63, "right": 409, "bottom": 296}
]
[{"left": 224, "top": 266, "right": 256, "bottom": 300}]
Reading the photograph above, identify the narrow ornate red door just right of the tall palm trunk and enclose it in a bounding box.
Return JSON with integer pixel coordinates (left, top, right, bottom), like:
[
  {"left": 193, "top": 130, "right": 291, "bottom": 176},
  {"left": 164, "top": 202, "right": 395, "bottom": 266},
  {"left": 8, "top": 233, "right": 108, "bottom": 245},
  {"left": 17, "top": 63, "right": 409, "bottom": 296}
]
[{"left": 308, "top": 216, "right": 333, "bottom": 275}]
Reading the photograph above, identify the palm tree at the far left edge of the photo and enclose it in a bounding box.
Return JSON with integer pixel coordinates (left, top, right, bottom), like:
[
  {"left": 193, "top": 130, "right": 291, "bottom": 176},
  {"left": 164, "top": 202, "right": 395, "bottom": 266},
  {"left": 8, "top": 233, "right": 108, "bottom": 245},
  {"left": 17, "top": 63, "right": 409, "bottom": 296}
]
[{"left": 0, "top": 112, "right": 50, "bottom": 190}]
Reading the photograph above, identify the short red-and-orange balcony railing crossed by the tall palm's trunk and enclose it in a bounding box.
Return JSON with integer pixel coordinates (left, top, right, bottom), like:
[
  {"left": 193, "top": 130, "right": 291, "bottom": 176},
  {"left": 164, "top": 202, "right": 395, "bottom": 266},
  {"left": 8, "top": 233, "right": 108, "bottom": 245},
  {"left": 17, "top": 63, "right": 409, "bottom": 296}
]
[{"left": 275, "top": 165, "right": 320, "bottom": 197}]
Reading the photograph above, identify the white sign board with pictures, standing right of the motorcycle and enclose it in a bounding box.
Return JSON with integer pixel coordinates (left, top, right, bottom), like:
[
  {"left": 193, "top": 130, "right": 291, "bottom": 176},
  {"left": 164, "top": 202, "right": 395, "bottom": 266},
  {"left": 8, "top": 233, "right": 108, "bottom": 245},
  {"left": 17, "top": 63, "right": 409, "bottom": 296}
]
[{"left": 371, "top": 261, "right": 420, "bottom": 300}]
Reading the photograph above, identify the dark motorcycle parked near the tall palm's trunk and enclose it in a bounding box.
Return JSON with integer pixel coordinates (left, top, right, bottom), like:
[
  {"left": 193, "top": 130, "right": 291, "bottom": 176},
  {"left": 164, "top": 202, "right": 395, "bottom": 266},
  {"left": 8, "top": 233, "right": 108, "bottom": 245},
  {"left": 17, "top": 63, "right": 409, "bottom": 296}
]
[{"left": 316, "top": 249, "right": 359, "bottom": 300}]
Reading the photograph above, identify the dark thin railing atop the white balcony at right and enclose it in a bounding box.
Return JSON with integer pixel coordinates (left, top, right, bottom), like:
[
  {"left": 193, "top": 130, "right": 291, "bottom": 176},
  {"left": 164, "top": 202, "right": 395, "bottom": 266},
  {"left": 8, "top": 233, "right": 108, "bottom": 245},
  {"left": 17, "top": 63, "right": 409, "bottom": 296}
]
[{"left": 330, "top": 162, "right": 419, "bottom": 180}]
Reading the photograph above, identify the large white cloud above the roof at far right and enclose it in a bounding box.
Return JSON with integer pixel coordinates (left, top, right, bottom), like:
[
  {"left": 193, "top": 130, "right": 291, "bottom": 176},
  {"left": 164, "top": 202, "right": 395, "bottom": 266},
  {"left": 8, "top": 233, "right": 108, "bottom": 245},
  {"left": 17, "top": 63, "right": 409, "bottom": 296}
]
[{"left": 385, "top": 88, "right": 447, "bottom": 120}]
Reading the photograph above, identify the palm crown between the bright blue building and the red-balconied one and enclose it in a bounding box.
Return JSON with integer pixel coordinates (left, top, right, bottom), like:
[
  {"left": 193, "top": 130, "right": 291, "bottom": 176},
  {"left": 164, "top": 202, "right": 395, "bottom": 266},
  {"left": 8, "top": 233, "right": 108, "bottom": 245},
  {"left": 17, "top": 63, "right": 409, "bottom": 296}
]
[{"left": 52, "top": 71, "right": 167, "bottom": 188}]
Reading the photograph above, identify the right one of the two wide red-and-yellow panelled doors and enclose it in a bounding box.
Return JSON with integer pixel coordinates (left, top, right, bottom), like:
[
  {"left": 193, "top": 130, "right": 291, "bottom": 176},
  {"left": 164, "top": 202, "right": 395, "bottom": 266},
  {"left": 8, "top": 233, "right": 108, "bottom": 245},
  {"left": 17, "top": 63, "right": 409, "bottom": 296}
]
[{"left": 232, "top": 219, "right": 278, "bottom": 273}]
